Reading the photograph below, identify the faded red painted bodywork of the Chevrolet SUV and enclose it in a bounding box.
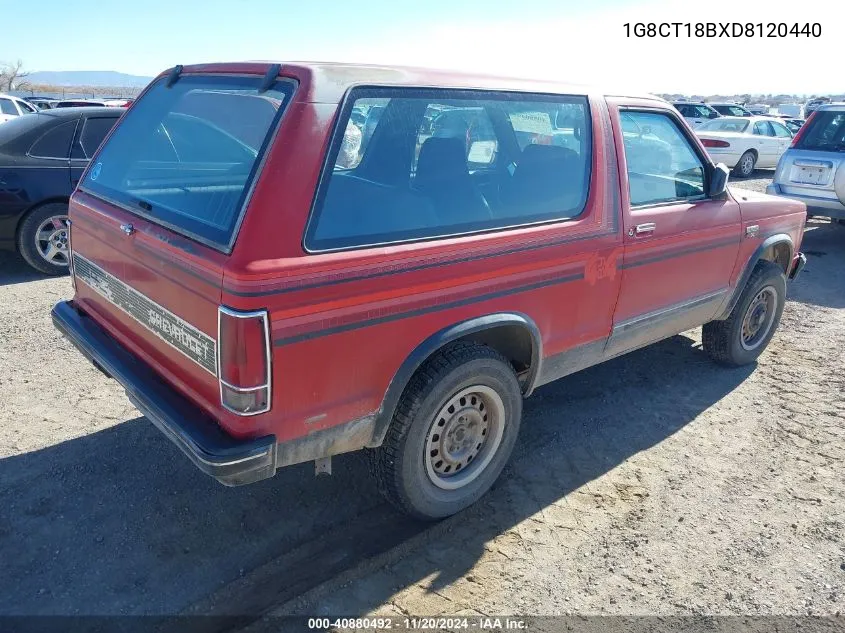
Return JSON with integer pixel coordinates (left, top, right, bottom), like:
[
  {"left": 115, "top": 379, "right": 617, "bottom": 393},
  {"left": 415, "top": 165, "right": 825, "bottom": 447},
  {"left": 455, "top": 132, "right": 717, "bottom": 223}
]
[{"left": 70, "top": 64, "right": 803, "bottom": 441}]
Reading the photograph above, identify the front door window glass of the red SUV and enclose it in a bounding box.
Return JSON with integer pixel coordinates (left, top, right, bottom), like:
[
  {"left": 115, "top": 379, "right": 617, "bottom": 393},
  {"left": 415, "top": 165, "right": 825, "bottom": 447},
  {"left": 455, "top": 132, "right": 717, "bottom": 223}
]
[{"left": 623, "top": 112, "right": 705, "bottom": 206}]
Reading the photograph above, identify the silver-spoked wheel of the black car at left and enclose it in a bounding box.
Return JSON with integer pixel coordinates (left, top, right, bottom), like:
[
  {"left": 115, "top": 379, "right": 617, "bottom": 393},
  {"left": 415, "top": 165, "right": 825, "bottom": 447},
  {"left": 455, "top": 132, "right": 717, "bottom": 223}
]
[{"left": 18, "top": 202, "right": 70, "bottom": 275}]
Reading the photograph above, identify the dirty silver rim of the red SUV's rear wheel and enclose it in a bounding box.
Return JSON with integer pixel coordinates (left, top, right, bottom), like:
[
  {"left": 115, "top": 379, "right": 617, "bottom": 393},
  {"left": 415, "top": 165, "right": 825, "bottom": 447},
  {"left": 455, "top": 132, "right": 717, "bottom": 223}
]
[{"left": 423, "top": 385, "right": 505, "bottom": 490}]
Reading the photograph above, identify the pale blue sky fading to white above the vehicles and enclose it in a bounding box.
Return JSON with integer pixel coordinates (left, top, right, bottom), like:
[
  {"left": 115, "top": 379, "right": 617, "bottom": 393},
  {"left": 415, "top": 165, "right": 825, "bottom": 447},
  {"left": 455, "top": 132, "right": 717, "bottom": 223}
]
[{"left": 0, "top": 0, "right": 845, "bottom": 95}]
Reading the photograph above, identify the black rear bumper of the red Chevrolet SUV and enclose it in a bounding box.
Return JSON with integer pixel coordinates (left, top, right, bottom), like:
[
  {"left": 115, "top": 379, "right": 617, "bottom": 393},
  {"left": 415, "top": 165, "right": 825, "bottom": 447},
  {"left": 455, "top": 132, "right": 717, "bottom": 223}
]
[{"left": 52, "top": 301, "right": 278, "bottom": 486}]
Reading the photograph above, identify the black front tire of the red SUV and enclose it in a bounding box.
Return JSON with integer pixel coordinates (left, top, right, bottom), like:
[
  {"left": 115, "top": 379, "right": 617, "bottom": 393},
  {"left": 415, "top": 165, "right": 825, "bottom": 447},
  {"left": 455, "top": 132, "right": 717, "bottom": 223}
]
[{"left": 702, "top": 261, "right": 786, "bottom": 367}]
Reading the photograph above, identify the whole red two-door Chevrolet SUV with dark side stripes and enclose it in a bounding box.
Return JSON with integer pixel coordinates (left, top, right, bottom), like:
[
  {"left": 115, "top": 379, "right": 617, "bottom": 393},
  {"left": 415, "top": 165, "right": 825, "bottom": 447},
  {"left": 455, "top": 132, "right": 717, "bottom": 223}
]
[{"left": 53, "top": 63, "right": 806, "bottom": 518}]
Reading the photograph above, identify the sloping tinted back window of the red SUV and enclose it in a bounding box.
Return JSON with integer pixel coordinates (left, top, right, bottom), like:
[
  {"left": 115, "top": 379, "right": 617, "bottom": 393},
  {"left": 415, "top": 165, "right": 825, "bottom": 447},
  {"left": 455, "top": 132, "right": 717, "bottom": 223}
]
[{"left": 82, "top": 75, "right": 292, "bottom": 250}]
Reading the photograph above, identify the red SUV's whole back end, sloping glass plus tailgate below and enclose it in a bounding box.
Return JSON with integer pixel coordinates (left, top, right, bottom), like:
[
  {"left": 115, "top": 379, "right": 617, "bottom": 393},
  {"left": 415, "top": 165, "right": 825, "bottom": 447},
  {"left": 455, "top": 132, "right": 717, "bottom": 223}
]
[{"left": 70, "top": 69, "right": 292, "bottom": 418}]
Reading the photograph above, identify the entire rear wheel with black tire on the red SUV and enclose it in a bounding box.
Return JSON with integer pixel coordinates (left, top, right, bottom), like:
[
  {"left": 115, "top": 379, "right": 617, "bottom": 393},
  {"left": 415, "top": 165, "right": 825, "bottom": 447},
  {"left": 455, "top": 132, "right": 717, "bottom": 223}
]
[{"left": 370, "top": 342, "right": 522, "bottom": 520}]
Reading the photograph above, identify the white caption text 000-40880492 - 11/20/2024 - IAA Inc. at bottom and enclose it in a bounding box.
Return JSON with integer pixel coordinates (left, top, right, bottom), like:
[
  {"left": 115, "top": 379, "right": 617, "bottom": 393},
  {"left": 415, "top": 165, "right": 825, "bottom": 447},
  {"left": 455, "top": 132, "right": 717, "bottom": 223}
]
[{"left": 308, "top": 616, "right": 528, "bottom": 631}]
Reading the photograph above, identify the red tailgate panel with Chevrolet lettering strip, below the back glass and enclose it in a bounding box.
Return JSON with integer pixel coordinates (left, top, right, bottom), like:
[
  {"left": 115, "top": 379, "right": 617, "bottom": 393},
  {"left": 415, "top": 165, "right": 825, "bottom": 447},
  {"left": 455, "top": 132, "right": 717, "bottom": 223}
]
[{"left": 70, "top": 192, "right": 223, "bottom": 413}]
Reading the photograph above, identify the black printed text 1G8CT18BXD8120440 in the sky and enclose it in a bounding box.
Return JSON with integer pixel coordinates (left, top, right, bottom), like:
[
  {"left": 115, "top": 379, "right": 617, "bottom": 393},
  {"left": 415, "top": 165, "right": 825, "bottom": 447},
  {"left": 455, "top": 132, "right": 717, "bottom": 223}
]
[{"left": 622, "top": 22, "right": 822, "bottom": 38}]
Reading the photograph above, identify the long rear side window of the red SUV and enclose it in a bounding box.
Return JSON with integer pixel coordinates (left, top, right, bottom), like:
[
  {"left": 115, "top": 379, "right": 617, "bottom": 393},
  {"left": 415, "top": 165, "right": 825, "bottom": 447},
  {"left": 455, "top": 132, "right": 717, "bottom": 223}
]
[{"left": 305, "top": 88, "right": 592, "bottom": 250}]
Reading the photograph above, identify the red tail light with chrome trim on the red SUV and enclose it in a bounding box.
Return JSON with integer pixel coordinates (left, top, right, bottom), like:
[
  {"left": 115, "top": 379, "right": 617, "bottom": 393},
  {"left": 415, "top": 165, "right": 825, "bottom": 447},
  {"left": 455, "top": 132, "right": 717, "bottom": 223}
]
[{"left": 217, "top": 306, "right": 272, "bottom": 415}]
